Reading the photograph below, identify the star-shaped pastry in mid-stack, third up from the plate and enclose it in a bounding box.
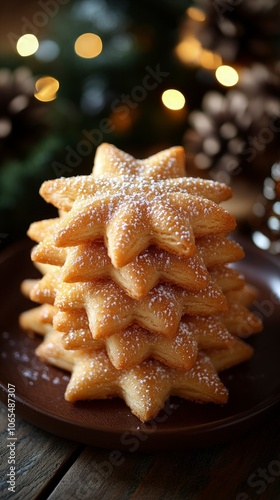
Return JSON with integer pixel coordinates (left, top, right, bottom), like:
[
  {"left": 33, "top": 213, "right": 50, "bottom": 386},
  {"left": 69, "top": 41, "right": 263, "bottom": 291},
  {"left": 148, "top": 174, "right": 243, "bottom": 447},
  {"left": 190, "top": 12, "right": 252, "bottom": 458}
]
[{"left": 26, "top": 266, "right": 254, "bottom": 338}]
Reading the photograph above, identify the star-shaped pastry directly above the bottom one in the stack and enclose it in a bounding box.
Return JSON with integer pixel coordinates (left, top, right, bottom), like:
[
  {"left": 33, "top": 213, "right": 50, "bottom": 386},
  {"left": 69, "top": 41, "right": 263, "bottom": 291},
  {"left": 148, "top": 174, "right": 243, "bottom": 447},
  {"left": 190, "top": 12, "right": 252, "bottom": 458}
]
[{"left": 62, "top": 312, "right": 234, "bottom": 370}]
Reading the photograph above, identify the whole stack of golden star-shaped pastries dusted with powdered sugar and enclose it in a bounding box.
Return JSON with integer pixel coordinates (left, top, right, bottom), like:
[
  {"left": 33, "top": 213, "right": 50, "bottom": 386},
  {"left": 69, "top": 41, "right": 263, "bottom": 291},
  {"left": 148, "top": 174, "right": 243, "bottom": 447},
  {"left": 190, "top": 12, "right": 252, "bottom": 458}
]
[{"left": 20, "top": 144, "right": 262, "bottom": 422}]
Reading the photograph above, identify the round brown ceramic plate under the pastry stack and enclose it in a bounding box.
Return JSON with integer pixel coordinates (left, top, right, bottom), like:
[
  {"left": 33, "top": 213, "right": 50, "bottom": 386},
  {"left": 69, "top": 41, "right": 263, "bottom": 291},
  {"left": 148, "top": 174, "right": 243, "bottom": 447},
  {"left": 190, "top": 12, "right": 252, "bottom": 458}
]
[{"left": 0, "top": 236, "right": 280, "bottom": 452}]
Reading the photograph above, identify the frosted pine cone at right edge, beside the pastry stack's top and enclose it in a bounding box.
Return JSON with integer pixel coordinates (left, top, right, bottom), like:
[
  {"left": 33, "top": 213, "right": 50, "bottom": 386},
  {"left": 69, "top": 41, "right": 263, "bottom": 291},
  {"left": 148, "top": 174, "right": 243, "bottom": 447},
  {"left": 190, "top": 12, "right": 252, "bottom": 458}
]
[{"left": 184, "top": 64, "right": 280, "bottom": 183}]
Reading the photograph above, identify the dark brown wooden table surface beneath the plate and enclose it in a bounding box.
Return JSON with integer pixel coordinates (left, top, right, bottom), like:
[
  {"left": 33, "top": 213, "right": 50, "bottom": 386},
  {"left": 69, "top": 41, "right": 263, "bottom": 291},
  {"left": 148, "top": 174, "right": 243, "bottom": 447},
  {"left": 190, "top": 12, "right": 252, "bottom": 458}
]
[{"left": 0, "top": 398, "right": 280, "bottom": 500}]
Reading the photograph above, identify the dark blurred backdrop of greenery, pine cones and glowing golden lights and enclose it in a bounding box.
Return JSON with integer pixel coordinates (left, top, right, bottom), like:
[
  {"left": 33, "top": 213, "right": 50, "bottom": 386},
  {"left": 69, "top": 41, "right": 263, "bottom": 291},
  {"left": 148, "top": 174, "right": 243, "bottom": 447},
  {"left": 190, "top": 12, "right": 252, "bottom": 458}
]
[{"left": 0, "top": 0, "right": 280, "bottom": 255}]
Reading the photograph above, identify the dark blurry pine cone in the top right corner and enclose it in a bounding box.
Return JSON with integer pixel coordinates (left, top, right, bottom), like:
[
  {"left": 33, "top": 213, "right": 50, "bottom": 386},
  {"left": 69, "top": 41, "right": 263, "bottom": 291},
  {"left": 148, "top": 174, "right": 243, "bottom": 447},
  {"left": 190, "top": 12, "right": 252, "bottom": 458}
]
[{"left": 197, "top": 0, "right": 280, "bottom": 64}]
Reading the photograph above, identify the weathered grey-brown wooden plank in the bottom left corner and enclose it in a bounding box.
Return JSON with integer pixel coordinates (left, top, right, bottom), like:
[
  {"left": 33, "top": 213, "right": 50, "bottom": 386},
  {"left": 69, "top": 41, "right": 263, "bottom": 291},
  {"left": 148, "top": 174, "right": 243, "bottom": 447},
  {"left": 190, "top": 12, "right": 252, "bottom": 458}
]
[{"left": 0, "top": 403, "right": 81, "bottom": 500}]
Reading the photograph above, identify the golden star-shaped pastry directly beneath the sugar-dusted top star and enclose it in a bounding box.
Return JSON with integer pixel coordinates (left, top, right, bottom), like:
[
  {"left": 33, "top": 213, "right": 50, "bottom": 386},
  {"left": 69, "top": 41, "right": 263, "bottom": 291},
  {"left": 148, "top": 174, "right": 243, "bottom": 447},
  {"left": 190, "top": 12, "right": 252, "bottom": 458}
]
[{"left": 31, "top": 229, "right": 244, "bottom": 300}]
